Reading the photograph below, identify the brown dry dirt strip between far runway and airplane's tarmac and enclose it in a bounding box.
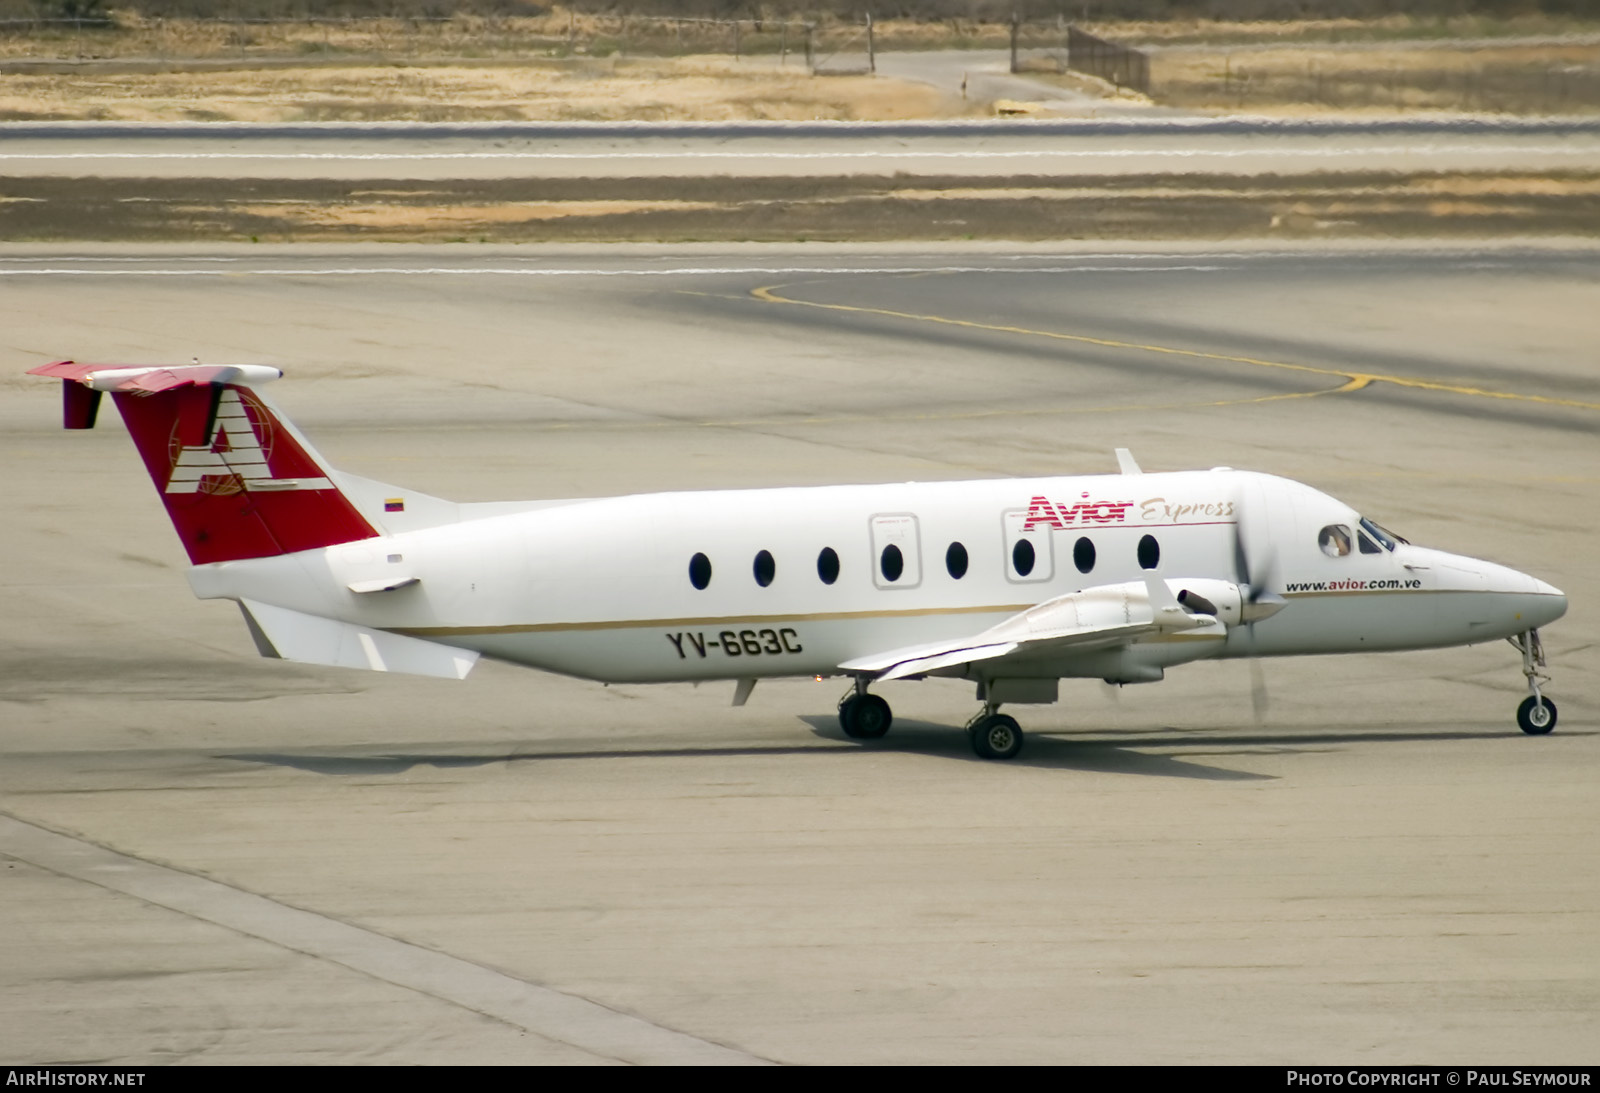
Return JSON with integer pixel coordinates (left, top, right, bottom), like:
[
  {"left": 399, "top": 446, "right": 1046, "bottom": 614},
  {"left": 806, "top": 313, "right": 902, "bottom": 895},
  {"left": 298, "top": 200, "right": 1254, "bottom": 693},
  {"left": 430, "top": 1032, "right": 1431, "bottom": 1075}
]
[{"left": 0, "top": 171, "right": 1600, "bottom": 242}]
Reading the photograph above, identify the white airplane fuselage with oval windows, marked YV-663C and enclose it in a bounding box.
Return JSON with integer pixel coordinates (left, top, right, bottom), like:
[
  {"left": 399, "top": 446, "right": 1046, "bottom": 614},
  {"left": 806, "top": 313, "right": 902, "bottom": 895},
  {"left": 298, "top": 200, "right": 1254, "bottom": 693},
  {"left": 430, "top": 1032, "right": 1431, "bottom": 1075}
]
[{"left": 184, "top": 470, "right": 1565, "bottom": 682}]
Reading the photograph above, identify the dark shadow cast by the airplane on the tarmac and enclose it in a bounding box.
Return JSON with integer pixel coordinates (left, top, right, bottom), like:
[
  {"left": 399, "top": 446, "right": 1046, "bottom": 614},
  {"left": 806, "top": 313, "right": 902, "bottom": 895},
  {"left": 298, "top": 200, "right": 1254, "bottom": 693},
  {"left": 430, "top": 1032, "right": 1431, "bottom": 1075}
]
[{"left": 218, "top": 715, "right": 1520, "bottom": 781}]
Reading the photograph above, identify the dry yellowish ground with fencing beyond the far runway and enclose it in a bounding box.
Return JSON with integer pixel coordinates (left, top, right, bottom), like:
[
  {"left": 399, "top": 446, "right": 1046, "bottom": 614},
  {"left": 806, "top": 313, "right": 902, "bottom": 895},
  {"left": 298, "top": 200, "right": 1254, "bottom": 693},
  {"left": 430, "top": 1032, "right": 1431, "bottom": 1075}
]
[{"left": 9, "top": 8, "right": 1600, "bottom": 122}]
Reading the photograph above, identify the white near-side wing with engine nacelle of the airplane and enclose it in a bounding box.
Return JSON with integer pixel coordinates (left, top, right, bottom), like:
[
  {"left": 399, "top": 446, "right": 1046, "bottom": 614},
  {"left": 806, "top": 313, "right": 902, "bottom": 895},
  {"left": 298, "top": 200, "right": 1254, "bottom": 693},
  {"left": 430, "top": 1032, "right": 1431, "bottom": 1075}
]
[{"left": 838, "top": 573, "right": 1227, "bottom": 680}]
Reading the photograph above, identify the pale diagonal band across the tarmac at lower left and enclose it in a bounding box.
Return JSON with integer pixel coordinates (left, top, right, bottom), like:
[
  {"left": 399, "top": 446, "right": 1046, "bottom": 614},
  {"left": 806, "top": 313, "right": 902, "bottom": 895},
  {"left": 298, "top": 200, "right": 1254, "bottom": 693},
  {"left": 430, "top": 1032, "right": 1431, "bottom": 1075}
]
[{"left": 0, "top": 815, "right": 766, "bottom": 1066}]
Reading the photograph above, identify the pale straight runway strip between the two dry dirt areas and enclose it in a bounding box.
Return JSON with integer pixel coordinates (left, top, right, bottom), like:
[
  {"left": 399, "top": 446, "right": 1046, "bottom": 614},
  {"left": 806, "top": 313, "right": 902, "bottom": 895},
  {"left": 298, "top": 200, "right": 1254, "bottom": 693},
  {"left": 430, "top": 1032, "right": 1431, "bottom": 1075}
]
[{"left": 0, "top": 115, "right": 1600, "bottom": 179}]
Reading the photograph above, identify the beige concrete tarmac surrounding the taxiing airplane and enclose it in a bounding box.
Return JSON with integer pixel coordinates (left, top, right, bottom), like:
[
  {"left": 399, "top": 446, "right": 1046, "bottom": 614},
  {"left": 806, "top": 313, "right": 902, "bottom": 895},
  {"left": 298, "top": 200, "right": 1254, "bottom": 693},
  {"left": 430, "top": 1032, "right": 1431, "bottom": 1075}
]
[{"left": 0, "top": 245, "right": 1600, "bottom": 1066}]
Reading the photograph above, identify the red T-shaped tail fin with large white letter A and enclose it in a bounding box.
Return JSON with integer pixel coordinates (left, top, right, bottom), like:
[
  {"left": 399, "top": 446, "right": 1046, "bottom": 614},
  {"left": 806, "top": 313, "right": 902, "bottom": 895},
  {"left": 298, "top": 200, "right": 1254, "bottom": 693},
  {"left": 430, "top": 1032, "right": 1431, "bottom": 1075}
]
[{"left": 29, "top": 360, "right": 378, "bottom": 565}]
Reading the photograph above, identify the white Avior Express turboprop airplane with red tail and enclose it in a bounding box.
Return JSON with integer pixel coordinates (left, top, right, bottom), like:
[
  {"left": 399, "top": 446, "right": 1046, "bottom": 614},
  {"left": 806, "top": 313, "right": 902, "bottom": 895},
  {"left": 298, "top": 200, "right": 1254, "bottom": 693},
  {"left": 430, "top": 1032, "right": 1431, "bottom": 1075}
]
[{"left": 32, "top": 362, "right": 1566, "bottom": 759}]
